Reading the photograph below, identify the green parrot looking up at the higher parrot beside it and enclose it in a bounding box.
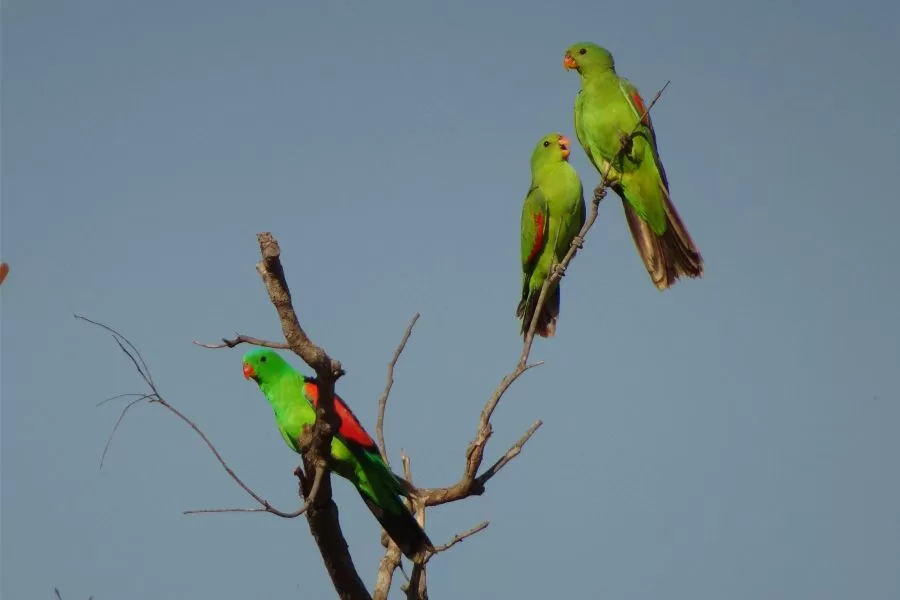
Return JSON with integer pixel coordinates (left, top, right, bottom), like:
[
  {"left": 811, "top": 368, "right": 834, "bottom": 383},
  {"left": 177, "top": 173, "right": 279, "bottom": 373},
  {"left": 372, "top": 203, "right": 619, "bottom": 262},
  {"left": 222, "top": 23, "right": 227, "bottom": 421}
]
[{"left": 516, "top": 133, "right": 585, "bottom": 337}]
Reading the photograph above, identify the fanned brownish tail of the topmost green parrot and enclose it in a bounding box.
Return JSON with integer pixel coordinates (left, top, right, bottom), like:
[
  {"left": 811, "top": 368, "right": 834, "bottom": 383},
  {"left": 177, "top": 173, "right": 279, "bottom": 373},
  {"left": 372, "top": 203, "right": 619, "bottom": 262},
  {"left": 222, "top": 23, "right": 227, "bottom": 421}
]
[{"left": 615, "top": 186, "right": 703, "bottom": 291}]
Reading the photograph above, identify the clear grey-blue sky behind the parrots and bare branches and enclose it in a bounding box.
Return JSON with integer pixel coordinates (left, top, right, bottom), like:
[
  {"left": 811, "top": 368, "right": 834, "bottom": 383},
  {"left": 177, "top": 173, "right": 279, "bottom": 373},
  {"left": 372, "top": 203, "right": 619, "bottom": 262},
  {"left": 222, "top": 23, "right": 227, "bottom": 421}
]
[{"left": 0, "top": 0, "right": 900, "bottom": 600}]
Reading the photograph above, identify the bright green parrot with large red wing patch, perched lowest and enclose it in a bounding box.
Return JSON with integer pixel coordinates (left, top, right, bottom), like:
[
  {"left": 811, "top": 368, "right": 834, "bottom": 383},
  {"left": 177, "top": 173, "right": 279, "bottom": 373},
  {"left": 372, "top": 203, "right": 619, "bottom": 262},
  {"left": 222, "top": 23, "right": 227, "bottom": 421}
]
[{"left": 243, "top": 348, "right": 434, "bottom": 560}]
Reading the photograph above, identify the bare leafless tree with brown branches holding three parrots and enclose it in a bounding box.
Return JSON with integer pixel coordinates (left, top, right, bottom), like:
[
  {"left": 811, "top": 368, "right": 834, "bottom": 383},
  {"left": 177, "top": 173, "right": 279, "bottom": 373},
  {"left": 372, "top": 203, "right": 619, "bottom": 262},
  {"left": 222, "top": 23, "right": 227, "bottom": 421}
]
[{"left": 76, "top": 83, "right": 668, "bottom": 600}]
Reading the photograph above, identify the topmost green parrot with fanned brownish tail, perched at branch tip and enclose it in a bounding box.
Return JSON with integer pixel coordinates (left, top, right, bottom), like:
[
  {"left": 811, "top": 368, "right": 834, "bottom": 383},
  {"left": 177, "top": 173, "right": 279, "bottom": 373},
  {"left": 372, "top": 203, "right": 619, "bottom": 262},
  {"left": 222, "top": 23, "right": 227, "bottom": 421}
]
[{"left": 563, "top": 42, "right": 703, "bottom": 291}]
